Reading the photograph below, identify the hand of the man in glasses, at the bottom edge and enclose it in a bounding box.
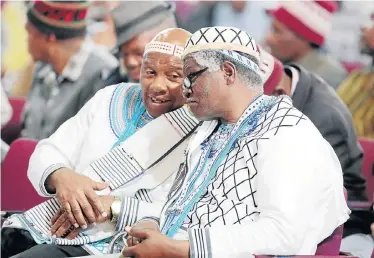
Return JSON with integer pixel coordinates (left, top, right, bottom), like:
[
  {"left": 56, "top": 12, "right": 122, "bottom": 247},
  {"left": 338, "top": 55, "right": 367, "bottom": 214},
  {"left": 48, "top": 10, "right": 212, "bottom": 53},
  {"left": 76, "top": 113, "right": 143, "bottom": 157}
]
[{"left": 122, "top": 227, "right": 189, "bottom": 258}]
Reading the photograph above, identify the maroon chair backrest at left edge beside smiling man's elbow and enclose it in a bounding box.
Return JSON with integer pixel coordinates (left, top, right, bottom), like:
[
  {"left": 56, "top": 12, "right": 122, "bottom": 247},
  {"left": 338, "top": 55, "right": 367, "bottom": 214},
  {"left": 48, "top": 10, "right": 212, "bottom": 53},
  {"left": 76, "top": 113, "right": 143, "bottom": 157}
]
[{"left": 1, "top": 138, "right": 47, "bottom": 211}]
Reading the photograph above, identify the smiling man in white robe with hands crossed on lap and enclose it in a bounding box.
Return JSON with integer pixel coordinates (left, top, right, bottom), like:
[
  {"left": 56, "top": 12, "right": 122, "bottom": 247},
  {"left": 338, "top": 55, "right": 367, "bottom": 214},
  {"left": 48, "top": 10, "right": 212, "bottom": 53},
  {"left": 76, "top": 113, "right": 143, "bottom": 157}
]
[{"left": 2, "top": 29, "right": 198, "bottom": 258}]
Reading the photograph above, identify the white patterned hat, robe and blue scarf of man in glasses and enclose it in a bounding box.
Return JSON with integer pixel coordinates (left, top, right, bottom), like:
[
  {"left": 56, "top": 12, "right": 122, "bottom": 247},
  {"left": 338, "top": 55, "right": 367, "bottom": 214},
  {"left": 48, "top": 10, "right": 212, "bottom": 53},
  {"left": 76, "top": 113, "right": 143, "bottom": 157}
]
[{"left": 148, "top": 27, "right": 350, "bottom": 257}]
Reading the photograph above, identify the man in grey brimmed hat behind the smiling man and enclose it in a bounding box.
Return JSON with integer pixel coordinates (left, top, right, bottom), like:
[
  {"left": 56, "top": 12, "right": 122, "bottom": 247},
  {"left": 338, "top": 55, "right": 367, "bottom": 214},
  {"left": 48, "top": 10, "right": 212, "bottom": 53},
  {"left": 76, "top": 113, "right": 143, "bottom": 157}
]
[{"left": 106, "top": 1, "right": 177, "bottom": 85}]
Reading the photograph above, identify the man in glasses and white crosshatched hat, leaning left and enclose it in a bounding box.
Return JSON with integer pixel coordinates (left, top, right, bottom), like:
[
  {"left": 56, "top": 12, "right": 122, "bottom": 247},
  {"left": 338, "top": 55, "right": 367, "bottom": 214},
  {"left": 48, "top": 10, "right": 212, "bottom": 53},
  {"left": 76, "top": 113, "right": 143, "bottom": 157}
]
[{"left": 123, "top": 27, "right": 349, "bottom": 257}]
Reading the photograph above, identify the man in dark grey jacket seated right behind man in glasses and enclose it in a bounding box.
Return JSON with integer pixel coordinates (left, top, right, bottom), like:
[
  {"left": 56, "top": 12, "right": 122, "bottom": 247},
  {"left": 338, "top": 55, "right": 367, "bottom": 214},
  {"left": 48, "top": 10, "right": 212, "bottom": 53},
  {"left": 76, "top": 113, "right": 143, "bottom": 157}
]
[{"left": 260, "top": 46, "right": 367, "bottom": 201}]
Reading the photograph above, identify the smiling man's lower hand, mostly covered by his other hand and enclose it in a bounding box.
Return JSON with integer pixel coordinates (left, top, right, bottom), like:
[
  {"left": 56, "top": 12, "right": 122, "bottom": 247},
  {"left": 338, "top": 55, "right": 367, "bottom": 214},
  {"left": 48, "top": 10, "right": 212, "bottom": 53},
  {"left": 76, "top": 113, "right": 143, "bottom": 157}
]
[{"left": 51, "top": 195, "right": 114, "bottom": 239}]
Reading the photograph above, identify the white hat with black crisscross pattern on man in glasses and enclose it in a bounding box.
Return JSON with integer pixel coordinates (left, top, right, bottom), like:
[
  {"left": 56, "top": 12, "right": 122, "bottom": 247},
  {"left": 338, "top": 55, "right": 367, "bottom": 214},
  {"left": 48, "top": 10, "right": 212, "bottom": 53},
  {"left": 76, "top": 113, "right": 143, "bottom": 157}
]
[{"left": 182, "top": 26, "right": 261, "bottom": 75}]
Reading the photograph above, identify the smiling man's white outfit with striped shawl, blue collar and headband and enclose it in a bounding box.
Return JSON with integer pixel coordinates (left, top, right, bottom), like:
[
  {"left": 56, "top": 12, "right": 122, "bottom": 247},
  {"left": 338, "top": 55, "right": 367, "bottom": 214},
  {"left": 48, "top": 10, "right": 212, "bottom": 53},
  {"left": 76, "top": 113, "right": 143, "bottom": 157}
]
[{"left": 4, "top": 39, "right": 198, "bottom": 254}]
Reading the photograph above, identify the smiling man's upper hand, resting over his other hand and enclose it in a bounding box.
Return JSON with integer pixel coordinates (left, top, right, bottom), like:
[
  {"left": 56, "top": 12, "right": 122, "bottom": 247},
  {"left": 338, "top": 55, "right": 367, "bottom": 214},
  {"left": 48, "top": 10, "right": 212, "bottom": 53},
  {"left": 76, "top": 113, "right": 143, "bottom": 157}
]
[{"left": 47, "top": 168, "right": 109, "bottom": 229}]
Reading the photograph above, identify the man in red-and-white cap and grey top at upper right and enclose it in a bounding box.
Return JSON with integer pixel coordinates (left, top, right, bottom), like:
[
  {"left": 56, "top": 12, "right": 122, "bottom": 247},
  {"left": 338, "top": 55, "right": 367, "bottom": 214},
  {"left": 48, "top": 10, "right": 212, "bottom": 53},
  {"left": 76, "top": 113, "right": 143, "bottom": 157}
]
[{"left": 266, "top": 1, "right": 347, "bottom": 89}]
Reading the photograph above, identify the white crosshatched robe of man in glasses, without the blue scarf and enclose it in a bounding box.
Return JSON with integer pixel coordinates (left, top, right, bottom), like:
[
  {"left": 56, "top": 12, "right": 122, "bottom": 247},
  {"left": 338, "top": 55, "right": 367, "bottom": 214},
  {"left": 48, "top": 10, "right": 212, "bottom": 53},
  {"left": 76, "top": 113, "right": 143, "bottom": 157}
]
[{"left": 160, "top": 96, "right": 350, "bottom": 257}]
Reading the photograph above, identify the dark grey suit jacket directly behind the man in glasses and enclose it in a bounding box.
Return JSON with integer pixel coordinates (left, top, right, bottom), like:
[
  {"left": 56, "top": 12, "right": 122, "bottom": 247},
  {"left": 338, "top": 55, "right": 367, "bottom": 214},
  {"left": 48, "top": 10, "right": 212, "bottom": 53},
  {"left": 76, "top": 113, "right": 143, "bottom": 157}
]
[{"left": 285, "top": 64, "right": 370, "bottom": 234}]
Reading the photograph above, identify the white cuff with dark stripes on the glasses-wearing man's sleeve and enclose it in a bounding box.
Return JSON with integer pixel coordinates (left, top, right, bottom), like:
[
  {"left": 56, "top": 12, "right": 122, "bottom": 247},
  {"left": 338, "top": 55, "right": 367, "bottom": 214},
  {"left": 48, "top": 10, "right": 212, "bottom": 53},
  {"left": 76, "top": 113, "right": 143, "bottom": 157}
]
[{"left": 188, "top": 228, "right": 212, "bottom": 258}]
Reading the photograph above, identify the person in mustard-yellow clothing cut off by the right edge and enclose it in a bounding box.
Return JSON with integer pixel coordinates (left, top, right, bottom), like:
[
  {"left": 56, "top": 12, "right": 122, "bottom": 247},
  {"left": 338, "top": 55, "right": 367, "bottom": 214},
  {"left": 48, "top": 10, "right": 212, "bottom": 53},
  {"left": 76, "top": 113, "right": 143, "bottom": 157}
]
[{"left": 338, "top": 13, "right": 374, "bottom": 139}]
